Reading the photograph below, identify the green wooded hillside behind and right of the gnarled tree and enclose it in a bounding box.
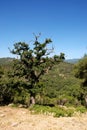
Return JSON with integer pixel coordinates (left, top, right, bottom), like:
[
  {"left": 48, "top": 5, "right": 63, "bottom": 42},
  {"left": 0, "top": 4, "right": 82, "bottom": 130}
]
[{"left": 39, "top": 62, "right": 82, "bottom": 104}]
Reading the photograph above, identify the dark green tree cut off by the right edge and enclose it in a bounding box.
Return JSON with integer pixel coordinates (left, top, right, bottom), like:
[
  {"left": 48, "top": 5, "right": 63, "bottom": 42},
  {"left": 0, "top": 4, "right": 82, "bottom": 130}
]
[{"left": 74, "top": 55, "right": 87, "bottom": 105}]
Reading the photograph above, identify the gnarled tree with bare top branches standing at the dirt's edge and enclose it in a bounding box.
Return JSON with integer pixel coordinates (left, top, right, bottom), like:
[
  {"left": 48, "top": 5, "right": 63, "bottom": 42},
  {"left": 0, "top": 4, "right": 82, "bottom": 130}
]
[{"left": 11, "top": 36, "right": 64, "bottom": 104}]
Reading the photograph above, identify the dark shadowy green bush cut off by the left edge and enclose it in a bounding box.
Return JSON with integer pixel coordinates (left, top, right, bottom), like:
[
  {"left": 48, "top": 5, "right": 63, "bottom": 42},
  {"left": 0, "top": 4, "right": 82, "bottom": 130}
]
[{"left": 0, "top": 66, "right": 12, "bottom": 105}]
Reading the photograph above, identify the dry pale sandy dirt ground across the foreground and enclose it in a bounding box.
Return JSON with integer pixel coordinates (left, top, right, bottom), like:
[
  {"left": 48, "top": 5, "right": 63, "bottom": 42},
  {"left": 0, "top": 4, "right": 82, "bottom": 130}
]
[{"left": 0, "top": 106, "right": 87, "bottom": 130}]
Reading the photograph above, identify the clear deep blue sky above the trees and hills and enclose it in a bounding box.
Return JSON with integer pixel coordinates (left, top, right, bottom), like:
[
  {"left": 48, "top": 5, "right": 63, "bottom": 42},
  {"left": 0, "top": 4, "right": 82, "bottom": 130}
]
[{"left": 0, "top": 0, "right": 87, "bottom": 59}]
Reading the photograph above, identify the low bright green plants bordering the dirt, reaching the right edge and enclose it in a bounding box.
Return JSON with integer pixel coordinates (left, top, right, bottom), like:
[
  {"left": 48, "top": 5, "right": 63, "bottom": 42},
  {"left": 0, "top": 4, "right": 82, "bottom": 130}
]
[{"left": 29, "top": 105, "right": 87, "bottom": 117}]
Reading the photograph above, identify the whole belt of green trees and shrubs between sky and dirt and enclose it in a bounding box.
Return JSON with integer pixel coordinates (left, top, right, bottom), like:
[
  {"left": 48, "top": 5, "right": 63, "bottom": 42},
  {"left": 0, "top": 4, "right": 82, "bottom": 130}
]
[{"left": 0, "top": 37, "right": 87, "bottom": 116}]
